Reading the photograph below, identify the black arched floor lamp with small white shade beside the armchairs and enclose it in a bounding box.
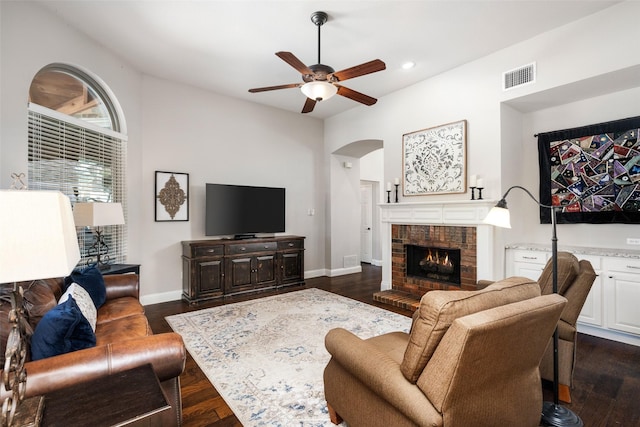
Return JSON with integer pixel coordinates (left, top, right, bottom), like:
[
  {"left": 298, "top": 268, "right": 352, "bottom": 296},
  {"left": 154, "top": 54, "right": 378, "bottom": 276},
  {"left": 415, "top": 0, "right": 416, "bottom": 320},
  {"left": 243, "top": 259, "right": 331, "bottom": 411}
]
[{"left": 484, "top": 185, "right": 584, "bottom": 427}]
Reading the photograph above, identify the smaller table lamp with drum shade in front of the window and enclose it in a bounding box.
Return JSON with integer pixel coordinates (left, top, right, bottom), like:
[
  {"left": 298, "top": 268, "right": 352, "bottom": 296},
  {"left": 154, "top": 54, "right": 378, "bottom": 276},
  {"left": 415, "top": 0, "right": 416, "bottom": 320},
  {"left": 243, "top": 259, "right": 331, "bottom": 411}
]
[{"left": 73, "top": 202, "right": 124, "bottom": 270}]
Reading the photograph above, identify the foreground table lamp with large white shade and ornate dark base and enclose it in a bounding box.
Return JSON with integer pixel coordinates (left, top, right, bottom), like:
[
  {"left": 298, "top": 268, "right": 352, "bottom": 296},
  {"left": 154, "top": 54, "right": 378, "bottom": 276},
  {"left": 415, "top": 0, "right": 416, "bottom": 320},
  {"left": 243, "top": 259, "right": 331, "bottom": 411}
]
[{"left": 0, "top": 190, "right": 80, "bottom": 425}]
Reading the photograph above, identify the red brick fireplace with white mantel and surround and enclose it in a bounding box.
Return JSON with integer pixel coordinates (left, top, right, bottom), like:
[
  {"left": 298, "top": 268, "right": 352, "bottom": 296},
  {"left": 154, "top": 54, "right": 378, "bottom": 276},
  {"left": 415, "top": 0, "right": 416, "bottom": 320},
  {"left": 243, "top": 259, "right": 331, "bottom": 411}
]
[{"left": 379, "top": 200, "right": 500, "bottom": 306}]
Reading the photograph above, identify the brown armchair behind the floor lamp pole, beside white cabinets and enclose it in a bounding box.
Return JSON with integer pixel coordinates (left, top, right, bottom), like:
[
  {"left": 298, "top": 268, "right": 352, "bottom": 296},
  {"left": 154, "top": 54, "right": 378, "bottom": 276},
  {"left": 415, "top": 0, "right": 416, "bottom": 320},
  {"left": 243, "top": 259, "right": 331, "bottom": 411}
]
[{"left": 538, "top": 252, "right": 596, "bottom": 403}]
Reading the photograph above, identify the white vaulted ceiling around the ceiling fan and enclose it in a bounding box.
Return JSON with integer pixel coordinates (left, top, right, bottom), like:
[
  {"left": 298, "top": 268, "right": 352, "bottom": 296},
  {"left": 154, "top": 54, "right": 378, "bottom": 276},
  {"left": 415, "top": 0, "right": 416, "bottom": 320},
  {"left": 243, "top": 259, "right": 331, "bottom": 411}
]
[{"left": 38, "top": 0, "right": 619, "bottom": 118}]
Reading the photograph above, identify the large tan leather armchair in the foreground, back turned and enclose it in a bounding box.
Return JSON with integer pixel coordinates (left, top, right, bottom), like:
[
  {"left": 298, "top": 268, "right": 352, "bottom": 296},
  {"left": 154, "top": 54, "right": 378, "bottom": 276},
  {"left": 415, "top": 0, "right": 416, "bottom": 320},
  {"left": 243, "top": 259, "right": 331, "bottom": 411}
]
[{"left": 324, "top": 277, "right": 566, "bottom": 427}]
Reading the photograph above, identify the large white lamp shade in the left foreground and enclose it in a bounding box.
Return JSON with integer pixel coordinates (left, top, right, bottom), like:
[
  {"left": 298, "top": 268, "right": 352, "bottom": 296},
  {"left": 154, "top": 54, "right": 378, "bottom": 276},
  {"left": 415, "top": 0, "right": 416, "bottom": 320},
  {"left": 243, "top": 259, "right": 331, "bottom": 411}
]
[{"left": 0, "top": 190, "right": 80, "bottom": 283}]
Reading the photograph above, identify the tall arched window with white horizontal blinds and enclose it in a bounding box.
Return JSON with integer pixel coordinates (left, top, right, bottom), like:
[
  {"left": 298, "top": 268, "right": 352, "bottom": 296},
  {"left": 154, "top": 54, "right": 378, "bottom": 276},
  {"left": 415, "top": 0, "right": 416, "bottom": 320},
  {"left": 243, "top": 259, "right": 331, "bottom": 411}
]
[{"left": 28, "top": 64, "right": 127, "bottom": 264}]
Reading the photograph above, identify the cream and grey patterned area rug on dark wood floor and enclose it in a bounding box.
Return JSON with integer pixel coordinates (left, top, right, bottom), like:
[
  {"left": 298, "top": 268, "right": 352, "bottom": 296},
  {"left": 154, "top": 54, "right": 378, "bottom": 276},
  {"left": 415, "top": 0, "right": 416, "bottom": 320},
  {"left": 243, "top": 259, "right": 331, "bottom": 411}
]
[{"left": 166, "top": 288, "right": 411, "bottom": 427}]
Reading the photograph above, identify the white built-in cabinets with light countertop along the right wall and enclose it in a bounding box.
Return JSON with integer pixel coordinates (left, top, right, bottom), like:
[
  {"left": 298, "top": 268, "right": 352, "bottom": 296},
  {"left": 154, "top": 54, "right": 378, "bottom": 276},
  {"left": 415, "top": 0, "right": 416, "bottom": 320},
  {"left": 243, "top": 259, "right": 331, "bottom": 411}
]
[{"left": 505, "top": 244, "right": 640, "bottom": 345}]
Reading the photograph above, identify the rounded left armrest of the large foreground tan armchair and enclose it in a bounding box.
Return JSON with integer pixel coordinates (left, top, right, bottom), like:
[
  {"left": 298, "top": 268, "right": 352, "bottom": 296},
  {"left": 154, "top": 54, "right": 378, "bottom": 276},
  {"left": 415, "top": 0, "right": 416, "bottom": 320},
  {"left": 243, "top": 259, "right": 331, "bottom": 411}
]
[{"left": 325, "top": 328, "right": 433, "bottom": 420}]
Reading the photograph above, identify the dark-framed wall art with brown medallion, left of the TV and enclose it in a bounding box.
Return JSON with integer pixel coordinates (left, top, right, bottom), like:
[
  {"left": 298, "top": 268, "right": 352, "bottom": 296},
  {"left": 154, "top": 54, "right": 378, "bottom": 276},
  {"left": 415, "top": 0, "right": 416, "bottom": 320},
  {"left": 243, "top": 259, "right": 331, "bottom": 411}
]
[{"left": 155, "top": 171, "right": 189, "bottom": 221}]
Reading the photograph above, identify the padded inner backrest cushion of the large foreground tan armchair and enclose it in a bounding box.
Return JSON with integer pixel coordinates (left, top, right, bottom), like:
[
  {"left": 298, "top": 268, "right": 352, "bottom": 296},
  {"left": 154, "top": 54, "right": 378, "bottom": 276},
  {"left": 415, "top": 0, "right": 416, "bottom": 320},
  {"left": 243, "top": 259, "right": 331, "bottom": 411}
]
[{"left": 400, "top": 277, "right": 540, "bottom": 383}]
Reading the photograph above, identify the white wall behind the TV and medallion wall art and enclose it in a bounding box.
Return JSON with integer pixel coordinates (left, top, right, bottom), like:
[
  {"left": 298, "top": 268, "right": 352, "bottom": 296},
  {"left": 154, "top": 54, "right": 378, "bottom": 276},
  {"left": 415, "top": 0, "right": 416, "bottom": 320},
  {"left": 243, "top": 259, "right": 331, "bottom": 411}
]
[{"left": 141, "top": 76, "right": 324, "bottom": 300}]
